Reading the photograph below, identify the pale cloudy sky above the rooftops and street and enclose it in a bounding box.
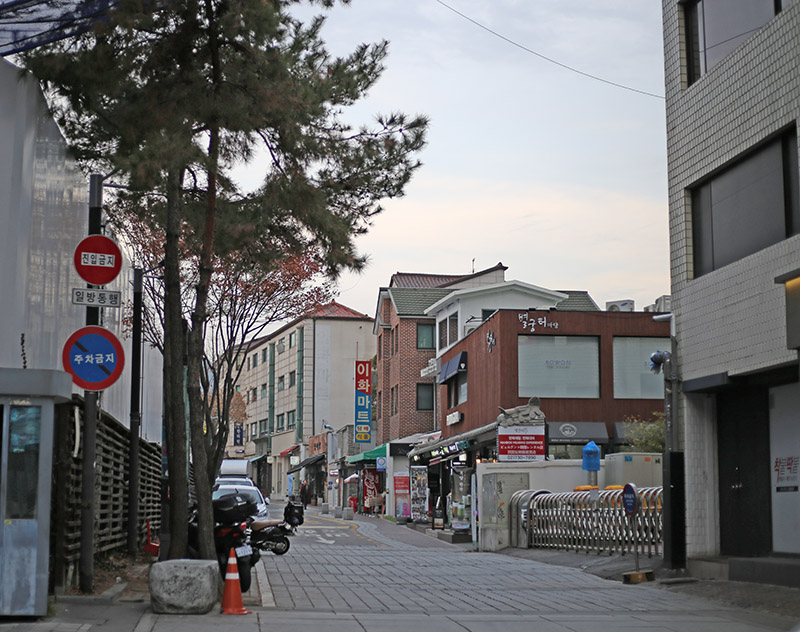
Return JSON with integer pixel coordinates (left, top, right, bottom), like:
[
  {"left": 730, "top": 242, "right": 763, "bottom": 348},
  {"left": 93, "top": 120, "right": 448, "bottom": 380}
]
[{"left": 236, "top": 0, "right": 669, "bottom": 316}]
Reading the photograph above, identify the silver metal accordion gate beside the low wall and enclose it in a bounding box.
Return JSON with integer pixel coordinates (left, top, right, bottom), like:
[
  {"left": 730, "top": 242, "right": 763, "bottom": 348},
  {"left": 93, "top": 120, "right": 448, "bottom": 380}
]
[{"left": 509, "top": 487, "right": 663, "bottom": 557}]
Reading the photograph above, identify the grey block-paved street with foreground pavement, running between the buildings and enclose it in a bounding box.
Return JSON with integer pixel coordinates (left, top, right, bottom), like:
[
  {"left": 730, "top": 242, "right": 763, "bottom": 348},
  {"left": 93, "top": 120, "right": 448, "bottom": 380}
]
[{"left": 0, "top": 507, "right": 800, "bottom": 632}]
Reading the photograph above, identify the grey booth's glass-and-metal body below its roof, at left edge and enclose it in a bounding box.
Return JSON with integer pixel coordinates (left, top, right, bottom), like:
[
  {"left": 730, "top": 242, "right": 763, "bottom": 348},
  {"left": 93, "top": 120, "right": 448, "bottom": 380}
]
[{"left": 0, "top": 398, "right": 53, "bottom": 616}]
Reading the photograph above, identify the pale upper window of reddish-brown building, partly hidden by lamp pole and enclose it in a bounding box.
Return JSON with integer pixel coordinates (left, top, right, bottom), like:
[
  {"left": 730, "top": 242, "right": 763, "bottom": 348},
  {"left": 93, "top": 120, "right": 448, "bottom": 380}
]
[{"left": 614, "top": 336, "right": 671, "bottom": 399}]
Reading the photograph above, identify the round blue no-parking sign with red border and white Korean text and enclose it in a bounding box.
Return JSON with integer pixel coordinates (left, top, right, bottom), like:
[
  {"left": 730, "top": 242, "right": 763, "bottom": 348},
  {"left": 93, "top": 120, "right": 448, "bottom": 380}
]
[{"left": 61, "top": 326, "right": 125, "bottom": 391}]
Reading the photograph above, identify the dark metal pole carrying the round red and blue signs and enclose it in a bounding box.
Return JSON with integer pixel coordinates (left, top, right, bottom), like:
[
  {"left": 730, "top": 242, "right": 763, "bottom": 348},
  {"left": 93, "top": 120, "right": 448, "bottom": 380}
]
[{"left": 78, "top": 174, "right": 103, "bottom": 593}]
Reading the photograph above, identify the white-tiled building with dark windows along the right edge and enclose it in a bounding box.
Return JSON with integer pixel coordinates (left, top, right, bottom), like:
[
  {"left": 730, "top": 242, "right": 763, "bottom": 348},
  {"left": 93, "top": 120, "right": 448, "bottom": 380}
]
[{"left": 662, "top": 0, "right": 800, "bottom": 585}]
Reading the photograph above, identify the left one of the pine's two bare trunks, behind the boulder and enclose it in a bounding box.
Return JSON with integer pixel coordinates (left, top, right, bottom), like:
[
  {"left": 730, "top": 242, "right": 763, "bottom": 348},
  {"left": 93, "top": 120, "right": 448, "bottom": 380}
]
[{"left": 164, "top": 169, "right": 189, "bottom": 559}]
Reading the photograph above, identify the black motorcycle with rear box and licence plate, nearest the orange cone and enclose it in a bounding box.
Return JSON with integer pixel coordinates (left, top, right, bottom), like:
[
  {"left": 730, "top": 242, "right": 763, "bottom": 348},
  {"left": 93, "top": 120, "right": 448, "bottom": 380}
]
[{"left": 189, "top": 493, "right": 261, "bottom": 592}]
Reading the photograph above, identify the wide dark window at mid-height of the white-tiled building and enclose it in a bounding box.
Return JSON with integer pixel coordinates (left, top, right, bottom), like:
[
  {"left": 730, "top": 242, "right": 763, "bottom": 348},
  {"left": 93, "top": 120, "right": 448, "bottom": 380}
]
[{"left": 690, "top": 130, "right": 800, "bottom": 277}]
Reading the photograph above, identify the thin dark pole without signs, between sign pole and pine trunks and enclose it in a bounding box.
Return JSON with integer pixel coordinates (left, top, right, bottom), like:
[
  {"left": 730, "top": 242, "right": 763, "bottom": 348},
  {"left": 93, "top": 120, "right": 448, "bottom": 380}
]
[{"left": 128, "top": 268, "right": 144, "bottom": 557}]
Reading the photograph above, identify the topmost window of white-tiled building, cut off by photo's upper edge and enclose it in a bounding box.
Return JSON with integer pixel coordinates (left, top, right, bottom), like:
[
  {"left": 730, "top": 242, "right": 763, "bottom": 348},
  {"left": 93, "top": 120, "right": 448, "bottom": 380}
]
[{"left": 683, "top": 0, "right": 791, "bottom": 85}]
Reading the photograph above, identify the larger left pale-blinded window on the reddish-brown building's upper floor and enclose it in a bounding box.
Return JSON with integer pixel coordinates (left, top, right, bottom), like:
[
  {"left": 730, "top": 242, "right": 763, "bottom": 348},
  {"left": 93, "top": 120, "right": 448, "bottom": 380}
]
[{"left": 517, "top": 335, "right": 600, "bottom": 398}]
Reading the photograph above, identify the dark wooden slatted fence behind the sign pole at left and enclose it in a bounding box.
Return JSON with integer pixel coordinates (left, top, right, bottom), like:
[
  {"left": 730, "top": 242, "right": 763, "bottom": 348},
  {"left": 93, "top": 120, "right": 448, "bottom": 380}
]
[{"left": 50, "top": 397, "right": 161, "bottom": 592}]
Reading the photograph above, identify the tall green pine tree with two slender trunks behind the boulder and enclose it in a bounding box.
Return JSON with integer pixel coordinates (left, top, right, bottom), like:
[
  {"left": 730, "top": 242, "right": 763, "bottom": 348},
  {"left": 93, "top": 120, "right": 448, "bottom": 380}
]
[{"left": 25, "top": 0, "right": 427, "bottom": 558}]
